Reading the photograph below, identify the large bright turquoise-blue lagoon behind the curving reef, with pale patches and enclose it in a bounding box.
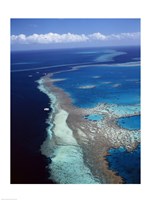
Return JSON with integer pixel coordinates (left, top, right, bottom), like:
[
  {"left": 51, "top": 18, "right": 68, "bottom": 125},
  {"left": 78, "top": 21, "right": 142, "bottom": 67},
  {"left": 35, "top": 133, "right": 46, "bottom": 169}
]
[{"left": 53, "top": 65, "right": 140, "bottom": 108}]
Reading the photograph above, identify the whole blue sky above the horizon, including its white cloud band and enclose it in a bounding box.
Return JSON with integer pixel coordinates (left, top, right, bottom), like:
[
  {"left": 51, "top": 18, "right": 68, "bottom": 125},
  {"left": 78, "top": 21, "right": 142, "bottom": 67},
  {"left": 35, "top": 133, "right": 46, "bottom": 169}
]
[{"left": 11, "top": 18, "right": 140, "bottom": 50}]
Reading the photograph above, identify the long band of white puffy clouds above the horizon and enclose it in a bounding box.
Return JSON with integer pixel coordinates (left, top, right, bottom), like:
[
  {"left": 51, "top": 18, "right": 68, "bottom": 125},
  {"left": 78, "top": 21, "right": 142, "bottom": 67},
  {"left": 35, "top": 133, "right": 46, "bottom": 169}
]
[{"left": 11, "top": 32, "right": 140, "bottom": 44}]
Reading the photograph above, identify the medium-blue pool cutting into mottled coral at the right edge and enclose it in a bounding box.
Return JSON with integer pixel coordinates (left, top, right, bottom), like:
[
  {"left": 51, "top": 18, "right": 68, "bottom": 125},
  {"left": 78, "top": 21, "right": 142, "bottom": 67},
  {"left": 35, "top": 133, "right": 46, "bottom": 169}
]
[{"left": 117, "top": 115, "right": 141, "bottom": 130}]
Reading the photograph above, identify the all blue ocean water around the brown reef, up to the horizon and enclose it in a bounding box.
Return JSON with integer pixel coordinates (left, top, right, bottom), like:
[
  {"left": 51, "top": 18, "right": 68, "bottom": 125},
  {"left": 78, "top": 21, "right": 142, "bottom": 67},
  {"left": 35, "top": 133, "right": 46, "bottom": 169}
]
[{"left": 11, "top": 47, "right": 140, "bottom": 184}]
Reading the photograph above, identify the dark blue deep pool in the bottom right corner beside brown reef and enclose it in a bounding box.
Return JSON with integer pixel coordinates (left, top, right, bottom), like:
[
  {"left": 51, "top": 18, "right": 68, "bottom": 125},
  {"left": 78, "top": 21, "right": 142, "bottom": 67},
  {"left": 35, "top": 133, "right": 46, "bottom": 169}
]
[{"left": 107, "top": 145, "right": 140, "bottom": 184}]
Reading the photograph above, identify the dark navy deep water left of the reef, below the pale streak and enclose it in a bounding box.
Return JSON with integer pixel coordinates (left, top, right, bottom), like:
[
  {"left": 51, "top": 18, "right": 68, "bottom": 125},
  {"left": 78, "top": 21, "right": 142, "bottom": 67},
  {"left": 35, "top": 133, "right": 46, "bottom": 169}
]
[{"left": 11, "top": 72, "right": 52, "bottom": 183}]
